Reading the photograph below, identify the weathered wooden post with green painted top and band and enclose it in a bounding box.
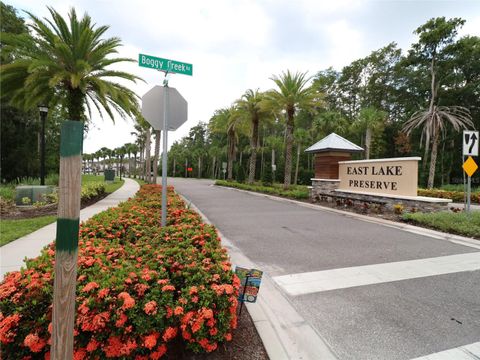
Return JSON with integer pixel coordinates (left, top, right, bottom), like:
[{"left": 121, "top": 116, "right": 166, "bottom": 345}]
[{"left": 51, "top": 121, "right": 83, "bottom": 360}]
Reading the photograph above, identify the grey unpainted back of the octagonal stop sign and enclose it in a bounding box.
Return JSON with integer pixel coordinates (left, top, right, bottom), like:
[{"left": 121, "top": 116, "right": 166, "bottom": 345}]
[{"left": 142, "top": 85, "right": 188, "bottom": 130}]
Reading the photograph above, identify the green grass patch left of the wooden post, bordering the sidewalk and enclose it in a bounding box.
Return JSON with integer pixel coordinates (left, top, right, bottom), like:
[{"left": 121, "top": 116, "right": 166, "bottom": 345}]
[{"left": 0, "top": 215, "right": 57, "bottom": 246}]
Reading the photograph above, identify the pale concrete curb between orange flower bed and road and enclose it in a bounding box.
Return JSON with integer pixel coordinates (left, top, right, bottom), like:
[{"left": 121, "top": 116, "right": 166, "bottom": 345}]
[{"left": 177, "top": 192, "right": 337, "bottom": 360}]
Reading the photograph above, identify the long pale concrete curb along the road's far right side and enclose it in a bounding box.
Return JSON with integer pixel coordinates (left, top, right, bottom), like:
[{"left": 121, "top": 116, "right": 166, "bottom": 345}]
[{"left": 215, "top": 185, "right": 480, "bottom": 249}]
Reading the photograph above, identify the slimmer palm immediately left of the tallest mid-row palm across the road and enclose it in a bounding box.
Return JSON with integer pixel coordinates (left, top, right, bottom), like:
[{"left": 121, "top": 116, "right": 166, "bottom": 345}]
[{"left": 236, "top": 89, "right": 271, "bottom": 184}]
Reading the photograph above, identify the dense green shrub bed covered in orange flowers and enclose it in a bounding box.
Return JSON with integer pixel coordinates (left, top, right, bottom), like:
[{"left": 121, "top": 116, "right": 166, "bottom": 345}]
[{"left": 0, "top": 185, "right": 239, "bottom": 359}]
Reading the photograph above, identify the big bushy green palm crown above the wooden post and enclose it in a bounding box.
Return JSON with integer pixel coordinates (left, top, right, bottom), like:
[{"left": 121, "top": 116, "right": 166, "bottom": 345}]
[{"left": 0, "top": 7, "right": 140, "bottom": 121}]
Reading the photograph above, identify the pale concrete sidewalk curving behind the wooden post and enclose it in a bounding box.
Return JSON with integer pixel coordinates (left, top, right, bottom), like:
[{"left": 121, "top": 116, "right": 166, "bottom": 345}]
[{"left": 0, "top": 178, "right": 140, "bottom": 280}]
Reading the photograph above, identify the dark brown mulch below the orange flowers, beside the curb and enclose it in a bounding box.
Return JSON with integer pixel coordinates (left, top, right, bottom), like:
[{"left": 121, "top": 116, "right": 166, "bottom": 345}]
[{"left": 166, "top": 307, "right": 269, "bottom": 360}]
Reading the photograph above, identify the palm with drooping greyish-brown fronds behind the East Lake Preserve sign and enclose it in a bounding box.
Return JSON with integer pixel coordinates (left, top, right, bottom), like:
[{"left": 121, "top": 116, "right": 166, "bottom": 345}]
[{"left": 402, "top": 105, "right": 475, "bottom": 189}]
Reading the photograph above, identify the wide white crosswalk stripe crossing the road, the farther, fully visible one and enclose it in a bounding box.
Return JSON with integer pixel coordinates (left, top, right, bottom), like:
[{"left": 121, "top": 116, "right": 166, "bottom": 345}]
[{"left": 273, "top": 252, "right": 480, "bottom": 296}]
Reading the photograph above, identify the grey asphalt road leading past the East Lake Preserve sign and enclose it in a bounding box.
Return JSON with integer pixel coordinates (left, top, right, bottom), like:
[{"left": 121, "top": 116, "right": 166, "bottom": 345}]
[{"left": 169, "top": 179, "right": 480, "bottom": 360}]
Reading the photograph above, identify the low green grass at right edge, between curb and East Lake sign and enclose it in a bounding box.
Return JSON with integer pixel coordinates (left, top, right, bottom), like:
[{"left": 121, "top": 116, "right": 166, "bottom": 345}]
[{"left": 403, "top": 211, "right": 480, "bottom": 238}]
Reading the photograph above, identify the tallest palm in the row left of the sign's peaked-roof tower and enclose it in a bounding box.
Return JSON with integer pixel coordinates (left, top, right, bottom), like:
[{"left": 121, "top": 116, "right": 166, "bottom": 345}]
[{"left": 267, "top": 71, "right": 319, "bottom": 188}]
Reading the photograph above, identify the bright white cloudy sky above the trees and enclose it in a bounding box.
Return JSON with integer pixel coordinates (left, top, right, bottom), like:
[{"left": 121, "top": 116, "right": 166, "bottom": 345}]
[{"left": 4, "top": 0, "right": 480, "bottom": 153}]
